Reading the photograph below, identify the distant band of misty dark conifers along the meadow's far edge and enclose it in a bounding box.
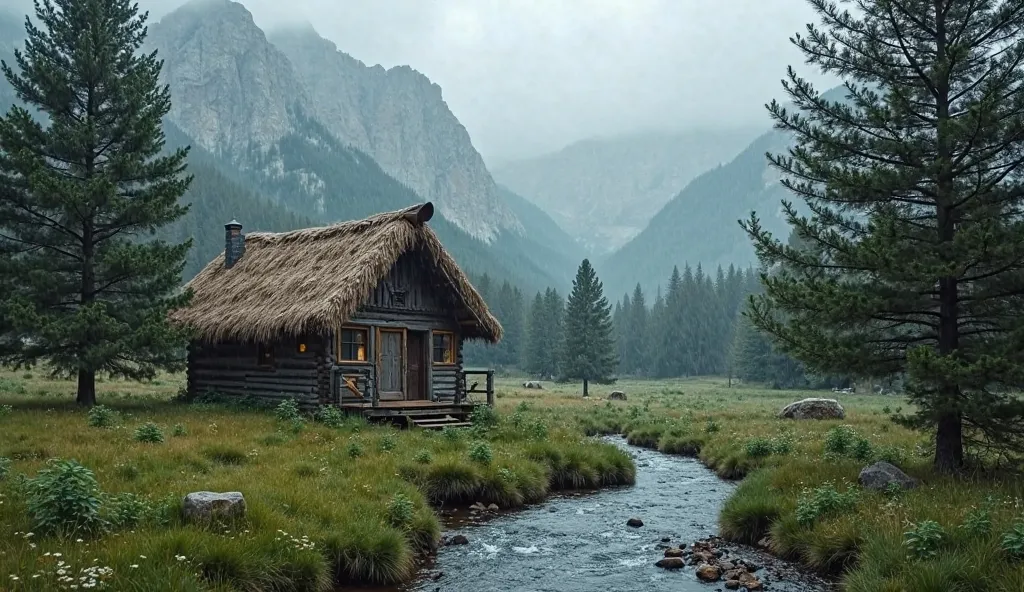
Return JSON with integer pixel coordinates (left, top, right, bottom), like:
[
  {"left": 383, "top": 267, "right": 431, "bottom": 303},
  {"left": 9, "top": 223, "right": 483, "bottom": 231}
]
[{"left": 465, "top": 257, "right": 847, "bottom": 388}]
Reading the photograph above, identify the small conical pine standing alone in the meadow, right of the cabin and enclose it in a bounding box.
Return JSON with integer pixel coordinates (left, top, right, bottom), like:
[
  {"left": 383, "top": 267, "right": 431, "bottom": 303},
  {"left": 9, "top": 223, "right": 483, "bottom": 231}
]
[{"left": 561, "top": 259, "right": 617, "bottom": 396}]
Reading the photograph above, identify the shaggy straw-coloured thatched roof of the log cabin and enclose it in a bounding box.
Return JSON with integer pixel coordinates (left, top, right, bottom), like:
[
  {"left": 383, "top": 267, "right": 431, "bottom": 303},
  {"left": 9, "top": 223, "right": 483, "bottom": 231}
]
[{"left": 171, "top": 202, "right": 502, "bottom": 341}]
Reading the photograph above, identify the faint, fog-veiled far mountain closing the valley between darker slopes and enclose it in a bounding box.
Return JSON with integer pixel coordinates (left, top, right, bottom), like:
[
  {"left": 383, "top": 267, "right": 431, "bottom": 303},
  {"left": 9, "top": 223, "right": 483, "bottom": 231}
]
[{"left": 494, "top": 129, "right": 758, "bottom": 254}]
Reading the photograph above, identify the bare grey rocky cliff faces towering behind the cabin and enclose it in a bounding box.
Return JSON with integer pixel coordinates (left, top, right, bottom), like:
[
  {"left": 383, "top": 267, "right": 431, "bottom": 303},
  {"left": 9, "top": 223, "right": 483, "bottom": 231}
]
[{"left": 148, "top": 0, "right": 523, "bottom": 242}]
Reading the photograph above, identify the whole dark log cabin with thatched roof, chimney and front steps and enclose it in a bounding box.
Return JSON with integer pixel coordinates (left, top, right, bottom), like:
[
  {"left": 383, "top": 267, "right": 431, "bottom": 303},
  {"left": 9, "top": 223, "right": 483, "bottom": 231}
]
[{"left": 171, "top": 202, "right": 502, "bottom": 427}]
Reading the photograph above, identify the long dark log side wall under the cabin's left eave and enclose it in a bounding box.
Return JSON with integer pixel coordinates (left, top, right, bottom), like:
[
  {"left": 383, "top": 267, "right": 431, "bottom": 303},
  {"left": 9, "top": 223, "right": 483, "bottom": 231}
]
[{"left": 187, "top": 336, "right": 330, "bottom": 408}]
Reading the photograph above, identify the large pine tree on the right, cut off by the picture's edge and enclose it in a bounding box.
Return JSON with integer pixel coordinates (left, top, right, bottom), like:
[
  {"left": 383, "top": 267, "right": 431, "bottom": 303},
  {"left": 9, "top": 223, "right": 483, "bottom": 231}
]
[{"left": 744, "top": 0, "right": 1024, "bottom": 472}]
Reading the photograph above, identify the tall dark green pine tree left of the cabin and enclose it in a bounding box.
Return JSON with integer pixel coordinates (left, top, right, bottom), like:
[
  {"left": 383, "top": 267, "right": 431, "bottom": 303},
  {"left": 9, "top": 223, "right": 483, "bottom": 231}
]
[{"left": 0, "top": 0, "right": 190, "bottom": 406}]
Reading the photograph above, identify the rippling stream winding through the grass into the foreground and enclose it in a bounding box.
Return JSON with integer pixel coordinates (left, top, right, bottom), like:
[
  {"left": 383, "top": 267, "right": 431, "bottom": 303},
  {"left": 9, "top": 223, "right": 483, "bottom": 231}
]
[{"left": 409, "top": 438, "right": 831, "bottom": 592}]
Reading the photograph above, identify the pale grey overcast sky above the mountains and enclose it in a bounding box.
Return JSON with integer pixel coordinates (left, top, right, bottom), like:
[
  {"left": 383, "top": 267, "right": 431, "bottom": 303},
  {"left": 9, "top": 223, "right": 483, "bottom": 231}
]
[{"left": 0, "top": 0, "right": 823, "bottom": 165}]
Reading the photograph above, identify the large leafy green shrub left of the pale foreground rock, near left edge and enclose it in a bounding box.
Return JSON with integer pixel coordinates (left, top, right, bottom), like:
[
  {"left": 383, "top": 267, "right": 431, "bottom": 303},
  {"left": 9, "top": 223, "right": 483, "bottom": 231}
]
[{"left": 28, "top": 459, "right": 102, "bottom": 535}]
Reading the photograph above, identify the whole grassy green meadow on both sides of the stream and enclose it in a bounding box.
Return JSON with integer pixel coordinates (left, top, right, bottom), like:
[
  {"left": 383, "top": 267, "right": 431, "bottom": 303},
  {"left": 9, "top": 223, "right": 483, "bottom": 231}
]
[{"left": 0, "top": 372, "right": 1024, "bottom": 592}]
